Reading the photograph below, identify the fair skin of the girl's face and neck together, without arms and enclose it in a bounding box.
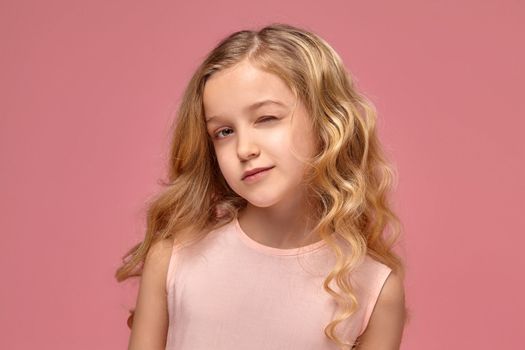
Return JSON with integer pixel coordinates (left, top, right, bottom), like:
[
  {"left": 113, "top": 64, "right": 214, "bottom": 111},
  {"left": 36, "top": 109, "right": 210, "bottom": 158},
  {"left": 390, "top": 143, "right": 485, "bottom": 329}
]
[{"left": 203, "top": 61, "right": 320, "bottom": 248}]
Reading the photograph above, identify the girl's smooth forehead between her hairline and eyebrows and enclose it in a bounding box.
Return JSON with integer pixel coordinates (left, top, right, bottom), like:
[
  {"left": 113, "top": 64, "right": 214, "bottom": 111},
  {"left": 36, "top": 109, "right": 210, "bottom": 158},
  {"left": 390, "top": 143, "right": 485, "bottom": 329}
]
[{"left": 203, "top": 61, "right": 295, "bottom": 119}]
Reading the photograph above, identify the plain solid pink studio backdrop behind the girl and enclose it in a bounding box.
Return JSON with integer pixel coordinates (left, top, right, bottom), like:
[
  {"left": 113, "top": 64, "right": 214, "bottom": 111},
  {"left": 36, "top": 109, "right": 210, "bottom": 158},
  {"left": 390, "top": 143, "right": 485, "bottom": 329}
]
[{"left": 0, "top": 0, "right": 525, "bottom": 350}]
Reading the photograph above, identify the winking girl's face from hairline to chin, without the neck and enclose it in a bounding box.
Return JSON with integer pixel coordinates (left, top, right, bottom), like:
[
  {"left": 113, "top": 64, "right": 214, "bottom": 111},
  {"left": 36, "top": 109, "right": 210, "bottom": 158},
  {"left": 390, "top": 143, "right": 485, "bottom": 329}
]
[{"left": 203, "top": 61, "right": 316, "bottom": 209}]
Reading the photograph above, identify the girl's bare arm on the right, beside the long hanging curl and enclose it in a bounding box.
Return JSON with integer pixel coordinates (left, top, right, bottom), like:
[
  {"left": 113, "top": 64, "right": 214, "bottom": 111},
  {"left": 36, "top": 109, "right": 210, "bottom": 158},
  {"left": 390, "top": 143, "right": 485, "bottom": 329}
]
[{"left": 357, "top": 272, "right": 406, "bottom": 350}]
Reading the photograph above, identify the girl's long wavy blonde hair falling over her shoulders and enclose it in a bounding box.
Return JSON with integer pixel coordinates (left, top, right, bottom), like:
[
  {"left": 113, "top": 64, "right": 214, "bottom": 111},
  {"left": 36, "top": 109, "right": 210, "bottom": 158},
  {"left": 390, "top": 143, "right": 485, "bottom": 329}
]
[{"left": 115, "top": 23, "right": 405, "bottom": 349}]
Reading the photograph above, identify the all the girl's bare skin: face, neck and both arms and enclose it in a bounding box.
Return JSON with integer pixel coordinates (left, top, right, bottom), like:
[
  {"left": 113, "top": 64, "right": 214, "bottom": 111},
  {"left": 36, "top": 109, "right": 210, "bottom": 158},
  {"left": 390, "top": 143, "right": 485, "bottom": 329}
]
[{"left": 128, "top": 58, "right": 405, "bottom": 350}]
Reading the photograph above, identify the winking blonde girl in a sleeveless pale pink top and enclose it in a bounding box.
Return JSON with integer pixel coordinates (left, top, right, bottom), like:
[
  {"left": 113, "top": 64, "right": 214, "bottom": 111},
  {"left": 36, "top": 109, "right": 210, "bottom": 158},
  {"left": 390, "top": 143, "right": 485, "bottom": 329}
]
[{"left": 116, "top": 24, "right": 406, "bottom": 350}]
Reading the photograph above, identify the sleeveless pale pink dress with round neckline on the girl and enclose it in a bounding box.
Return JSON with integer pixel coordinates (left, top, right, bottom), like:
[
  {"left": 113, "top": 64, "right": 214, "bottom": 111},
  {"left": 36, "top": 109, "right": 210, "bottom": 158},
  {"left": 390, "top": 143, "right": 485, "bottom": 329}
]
[{"left": 166, "top": 219, "right": 391, "bottom": 350}]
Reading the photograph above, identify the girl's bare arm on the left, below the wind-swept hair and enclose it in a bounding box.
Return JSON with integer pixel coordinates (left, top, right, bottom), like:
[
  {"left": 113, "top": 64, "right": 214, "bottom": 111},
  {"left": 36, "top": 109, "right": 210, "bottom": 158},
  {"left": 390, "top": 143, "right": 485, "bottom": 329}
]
[{"left": 128, "top": 239, "right": 173, "bottom": 350}]
